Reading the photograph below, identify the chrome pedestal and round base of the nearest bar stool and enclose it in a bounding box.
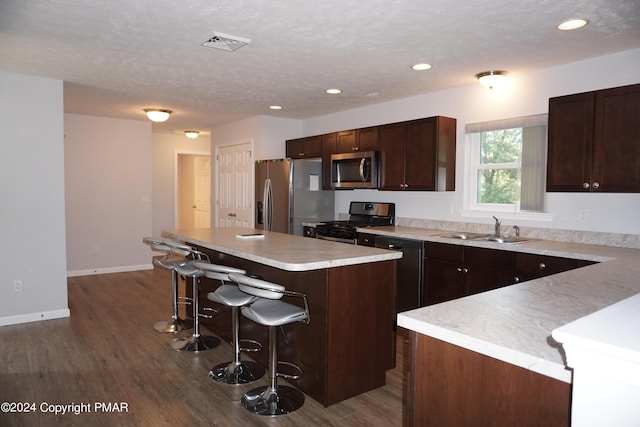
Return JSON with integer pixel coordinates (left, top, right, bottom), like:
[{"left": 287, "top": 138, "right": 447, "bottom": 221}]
[{"left": 241, "top": 326, "right": 304, "bottom": 416}]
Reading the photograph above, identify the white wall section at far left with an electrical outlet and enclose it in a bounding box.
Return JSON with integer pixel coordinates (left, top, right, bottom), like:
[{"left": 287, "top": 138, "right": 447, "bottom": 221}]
[{"left": 0, "top": 73, "right": 69, "bottom": 326}]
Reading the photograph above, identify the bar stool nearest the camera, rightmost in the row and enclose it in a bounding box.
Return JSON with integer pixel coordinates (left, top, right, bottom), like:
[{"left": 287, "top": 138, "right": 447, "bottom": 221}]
[{"left": 229, "top": 273, "right": 310, "bottom": 416}]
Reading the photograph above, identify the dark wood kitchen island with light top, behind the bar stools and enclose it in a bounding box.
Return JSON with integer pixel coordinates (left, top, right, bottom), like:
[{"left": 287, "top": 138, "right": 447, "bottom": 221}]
[{"left": 162, "top": 228, "right": 402, "bottom": 406}]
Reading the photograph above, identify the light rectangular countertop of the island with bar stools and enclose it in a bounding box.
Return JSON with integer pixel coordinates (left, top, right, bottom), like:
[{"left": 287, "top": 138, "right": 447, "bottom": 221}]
[{"left": 162, "top": 228, "right": 402, "bottom": 271}]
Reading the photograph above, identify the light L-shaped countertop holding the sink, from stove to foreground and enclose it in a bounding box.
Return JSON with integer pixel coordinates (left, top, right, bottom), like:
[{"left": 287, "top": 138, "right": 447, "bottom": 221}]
[{"left": 361, "top": 227, "right": 640, "bottom": 383}]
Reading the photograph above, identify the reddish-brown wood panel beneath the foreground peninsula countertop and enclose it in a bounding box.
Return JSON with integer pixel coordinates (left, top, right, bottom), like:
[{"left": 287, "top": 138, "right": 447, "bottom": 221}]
[{"left": 403, "top": 332, "right": 571, "bottom": 427}]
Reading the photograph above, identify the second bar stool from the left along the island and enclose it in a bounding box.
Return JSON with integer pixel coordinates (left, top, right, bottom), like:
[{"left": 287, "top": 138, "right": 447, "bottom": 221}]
[{"left": 171, "top": 249, "right": 220, "bottom": 352}]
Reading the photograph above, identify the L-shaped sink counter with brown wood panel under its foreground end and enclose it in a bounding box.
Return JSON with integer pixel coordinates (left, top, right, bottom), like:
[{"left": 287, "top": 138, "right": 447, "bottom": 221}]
[{"left": 366, "top": 227, "right": 640, "bottom": 426}]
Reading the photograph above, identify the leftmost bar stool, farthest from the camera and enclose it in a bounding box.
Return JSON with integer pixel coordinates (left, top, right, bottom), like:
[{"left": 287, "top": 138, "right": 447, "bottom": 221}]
[{"left": 142, "top": 237, "right": 193, "bottom": 333}]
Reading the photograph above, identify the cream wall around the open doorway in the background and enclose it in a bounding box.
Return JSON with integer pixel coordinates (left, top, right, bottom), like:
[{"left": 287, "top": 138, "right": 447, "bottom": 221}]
[{"left": 151, "top": 133, "right": 211, "bottom": 236}]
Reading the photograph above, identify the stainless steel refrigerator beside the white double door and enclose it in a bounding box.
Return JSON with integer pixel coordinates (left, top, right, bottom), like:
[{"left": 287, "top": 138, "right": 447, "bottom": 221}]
[{"left": 254, "top": 159, "right": 334, "bottom": 236}]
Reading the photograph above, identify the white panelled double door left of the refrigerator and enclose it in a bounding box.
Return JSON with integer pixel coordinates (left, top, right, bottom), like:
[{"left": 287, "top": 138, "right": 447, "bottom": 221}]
[{"left": 216, "top": 142, "right": 253, "bottom": 228}]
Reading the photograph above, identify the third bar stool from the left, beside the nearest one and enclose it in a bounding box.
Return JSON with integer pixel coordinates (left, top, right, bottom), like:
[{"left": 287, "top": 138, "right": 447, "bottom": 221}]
[{"left": 200, "top": 262, "right": 265, "bottom": 385}]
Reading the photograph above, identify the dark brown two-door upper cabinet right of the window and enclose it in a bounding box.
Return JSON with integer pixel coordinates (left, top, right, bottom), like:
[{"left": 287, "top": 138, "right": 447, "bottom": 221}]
[{"left": 547, "top": 84, "right": 640, "bottom": 193}]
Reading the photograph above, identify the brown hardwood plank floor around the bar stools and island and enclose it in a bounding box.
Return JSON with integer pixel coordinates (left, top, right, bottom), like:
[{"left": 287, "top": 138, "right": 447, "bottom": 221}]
[{"left": 0, "top": 269, "right": 407, "bottom": 427}]
